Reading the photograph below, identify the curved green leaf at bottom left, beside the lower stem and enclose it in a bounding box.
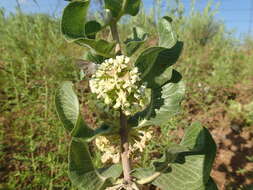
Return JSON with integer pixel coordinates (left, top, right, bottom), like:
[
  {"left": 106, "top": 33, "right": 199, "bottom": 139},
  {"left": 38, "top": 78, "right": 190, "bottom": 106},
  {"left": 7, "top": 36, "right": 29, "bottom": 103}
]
[{"left": 69, "top": 140, "right": 122, "bottom": 190}]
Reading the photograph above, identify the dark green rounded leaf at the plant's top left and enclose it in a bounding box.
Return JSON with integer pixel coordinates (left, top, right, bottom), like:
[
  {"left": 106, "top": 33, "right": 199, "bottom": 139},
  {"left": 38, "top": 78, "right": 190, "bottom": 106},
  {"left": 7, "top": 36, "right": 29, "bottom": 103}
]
[{"left": 61, "top": 0, "right": 90, "bottom": 40}]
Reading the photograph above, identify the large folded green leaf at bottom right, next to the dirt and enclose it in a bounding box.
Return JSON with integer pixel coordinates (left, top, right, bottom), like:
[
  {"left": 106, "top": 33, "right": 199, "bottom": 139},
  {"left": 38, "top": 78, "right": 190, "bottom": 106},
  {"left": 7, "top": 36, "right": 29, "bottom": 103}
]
[{"left": 133, "top": 123, "right": 216, "bottom": 190}]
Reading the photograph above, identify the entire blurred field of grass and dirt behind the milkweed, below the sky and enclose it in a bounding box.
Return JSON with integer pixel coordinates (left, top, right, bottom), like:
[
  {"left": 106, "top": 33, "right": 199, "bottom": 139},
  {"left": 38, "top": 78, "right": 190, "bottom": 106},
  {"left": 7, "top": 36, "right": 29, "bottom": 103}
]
[{"left": 0, "top": 0, "right": 253, "bottom": 190}]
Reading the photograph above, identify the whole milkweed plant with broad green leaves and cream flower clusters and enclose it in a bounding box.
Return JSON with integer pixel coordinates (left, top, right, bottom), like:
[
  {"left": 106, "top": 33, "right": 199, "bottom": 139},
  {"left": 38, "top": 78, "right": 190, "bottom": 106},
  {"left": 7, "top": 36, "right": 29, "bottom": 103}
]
[{"left": 55, "top": 0, "right": 217, "bottom": 190}]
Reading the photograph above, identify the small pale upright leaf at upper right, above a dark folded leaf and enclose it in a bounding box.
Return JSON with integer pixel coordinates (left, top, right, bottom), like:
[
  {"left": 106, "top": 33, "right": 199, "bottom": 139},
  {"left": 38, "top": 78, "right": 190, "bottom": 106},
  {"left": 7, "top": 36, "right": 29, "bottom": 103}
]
[{"left": 158, "top": 16, "right": 177, "bottom": 48}]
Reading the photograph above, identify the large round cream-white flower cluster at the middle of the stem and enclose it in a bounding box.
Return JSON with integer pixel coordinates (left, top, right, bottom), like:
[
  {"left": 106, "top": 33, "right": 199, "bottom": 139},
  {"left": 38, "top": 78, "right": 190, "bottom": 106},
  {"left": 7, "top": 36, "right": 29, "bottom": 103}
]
[{"left": 89, "top": 55, "right": 145, "bottom": 115}]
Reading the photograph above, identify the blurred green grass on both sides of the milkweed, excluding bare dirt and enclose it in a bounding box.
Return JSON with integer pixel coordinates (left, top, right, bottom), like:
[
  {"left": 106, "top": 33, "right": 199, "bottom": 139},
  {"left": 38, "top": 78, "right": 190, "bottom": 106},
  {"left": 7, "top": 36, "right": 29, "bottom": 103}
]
[{"left": 0, "top": 0, "right": 253, "bottom": 190}]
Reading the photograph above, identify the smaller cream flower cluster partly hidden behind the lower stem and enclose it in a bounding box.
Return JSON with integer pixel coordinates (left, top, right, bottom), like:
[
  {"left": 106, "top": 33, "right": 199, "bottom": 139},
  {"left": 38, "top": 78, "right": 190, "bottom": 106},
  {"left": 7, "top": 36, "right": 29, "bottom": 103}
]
[{"left": 95, "top": 130, "right": 152, "bottom": 163}]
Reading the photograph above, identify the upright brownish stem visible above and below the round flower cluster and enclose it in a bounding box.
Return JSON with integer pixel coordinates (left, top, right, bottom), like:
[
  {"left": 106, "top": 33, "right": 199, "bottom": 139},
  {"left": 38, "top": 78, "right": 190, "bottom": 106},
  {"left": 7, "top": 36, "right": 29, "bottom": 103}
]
[{"left": 110, "top": 23, "right": 131, "bottom": 184}]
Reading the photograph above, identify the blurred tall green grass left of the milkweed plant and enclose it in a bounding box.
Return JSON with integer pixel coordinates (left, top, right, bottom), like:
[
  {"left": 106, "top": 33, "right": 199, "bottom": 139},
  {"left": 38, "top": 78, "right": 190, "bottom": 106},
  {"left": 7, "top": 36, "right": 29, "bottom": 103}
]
[{"left": 0, "top": 9, "right": 81, "bottom": 189}]
